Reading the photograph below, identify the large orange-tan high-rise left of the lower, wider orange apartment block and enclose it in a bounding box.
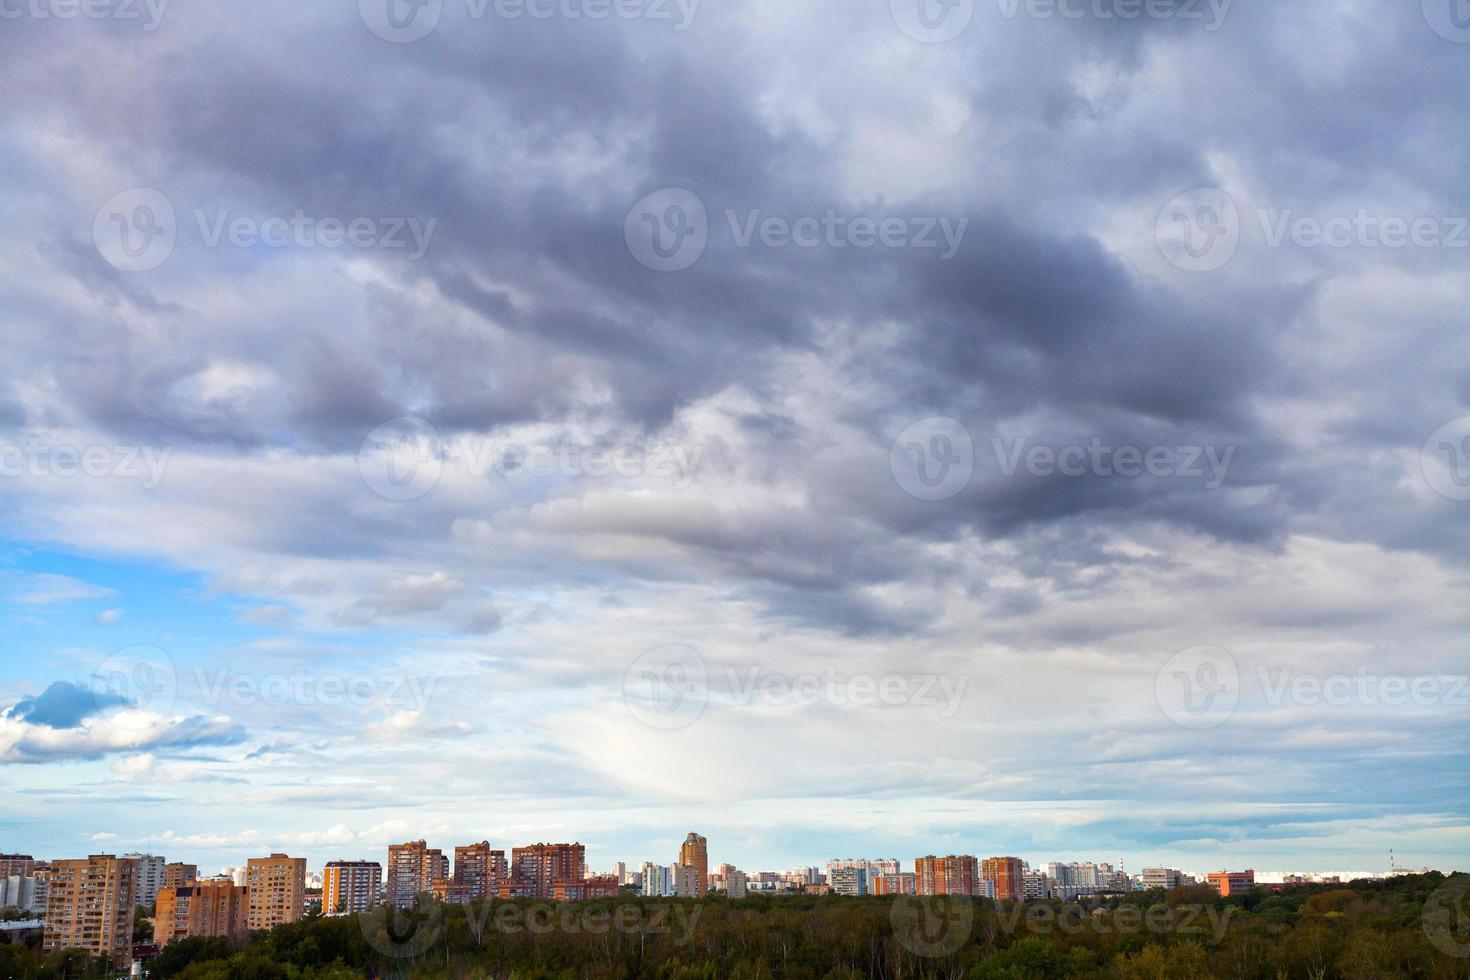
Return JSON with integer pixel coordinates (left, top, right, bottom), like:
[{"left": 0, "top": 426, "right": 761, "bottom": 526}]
[{"left": 43, "top": 854, "right": 138, "bottom": 967}]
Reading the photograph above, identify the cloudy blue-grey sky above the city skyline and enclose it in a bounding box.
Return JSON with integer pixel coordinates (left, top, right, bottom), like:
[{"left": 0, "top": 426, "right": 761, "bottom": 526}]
[{"left": 0, "top": 0, "right": 1470, "bottom": 871}]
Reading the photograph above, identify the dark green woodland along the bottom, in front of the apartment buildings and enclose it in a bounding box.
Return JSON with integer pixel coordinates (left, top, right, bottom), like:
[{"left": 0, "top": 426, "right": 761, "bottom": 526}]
[{"left": 0, "top": 874, "right": 1470, "bottom": 980}]
